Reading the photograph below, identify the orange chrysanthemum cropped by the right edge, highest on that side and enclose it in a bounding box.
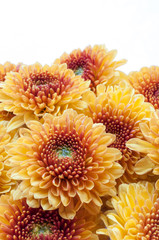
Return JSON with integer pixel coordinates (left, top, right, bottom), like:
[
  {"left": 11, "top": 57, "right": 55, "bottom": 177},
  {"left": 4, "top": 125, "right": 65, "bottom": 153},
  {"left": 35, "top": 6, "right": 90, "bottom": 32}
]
[{"left": 128, "top": 66, "right": 159, "bottom": 109}]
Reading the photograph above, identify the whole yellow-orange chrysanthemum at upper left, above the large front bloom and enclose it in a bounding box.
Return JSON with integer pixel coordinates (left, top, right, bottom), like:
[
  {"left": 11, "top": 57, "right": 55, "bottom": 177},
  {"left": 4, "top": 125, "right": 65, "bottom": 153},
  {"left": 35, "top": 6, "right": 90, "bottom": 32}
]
[{"left": 0, "top": 63, "right": 89, "bottom": 127}]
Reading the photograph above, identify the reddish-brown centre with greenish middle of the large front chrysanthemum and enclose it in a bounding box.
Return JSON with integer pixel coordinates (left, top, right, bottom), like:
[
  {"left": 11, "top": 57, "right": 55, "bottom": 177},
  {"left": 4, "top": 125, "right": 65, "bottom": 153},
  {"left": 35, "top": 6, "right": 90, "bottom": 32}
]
[{"left": 39, "top": 131, "right": 87, "bottom": 179}]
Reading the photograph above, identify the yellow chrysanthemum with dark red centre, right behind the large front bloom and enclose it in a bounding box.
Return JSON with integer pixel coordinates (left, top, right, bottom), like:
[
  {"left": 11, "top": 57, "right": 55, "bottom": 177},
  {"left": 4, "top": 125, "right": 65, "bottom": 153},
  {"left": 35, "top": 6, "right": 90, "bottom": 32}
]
[{"left": 83, "top": 82, "right": 154, "bottom": 182}]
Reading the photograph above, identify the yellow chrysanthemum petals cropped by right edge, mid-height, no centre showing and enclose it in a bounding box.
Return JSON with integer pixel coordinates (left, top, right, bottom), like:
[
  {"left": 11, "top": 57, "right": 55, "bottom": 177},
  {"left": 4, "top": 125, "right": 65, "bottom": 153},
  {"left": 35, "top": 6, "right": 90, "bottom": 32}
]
[{"left": 127, "top": 110, "right": 159, "bottom": 189}]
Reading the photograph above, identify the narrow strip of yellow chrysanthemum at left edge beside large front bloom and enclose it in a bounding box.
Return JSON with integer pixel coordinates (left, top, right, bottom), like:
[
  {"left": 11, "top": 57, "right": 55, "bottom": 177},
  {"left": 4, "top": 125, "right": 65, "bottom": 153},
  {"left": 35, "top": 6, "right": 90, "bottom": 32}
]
[{"left": 0, "top": 124, "right": 15, "bottom": 194}]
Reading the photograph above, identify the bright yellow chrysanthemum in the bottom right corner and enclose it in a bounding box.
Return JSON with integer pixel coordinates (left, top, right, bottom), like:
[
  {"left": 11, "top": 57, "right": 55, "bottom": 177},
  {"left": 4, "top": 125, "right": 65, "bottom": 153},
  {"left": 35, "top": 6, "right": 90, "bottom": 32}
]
[{"left": 97, "top": 182, "right": 159, "bottom": 240}]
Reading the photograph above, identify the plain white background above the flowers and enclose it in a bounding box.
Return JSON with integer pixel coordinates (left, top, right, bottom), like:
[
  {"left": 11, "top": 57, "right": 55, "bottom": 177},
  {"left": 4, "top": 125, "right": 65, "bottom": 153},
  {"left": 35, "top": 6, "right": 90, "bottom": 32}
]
[{"left": 0, "top": 0, "right": 159, "bottom": 73}]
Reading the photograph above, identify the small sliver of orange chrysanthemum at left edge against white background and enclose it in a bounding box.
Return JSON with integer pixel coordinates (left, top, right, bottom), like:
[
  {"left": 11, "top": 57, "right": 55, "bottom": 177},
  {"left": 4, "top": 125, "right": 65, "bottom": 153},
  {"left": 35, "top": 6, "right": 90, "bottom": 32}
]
[{"left": 0, "top": 62, "right": 21, "bottom": 82}]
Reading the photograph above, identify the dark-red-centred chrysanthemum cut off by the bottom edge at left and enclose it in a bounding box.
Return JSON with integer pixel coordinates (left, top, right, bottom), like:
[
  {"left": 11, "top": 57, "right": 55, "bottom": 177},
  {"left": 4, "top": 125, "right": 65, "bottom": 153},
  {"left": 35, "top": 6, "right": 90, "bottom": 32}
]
[{"left": 0, "top": 195, "right": 99, "bottom": 240}]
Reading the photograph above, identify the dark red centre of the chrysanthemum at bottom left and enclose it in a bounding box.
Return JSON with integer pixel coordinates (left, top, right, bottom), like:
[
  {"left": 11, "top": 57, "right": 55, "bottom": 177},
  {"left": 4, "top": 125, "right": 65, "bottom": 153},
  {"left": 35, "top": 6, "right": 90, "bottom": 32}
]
[{"left": 1, "top": 202, "right": 82, "bottom": 240}]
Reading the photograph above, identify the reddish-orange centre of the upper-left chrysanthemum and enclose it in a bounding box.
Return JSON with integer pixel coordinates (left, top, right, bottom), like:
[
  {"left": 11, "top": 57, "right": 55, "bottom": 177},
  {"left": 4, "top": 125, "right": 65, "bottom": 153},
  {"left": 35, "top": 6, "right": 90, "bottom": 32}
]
[{"left": 17, "top": 71, "right": 74, "bottom": 115}]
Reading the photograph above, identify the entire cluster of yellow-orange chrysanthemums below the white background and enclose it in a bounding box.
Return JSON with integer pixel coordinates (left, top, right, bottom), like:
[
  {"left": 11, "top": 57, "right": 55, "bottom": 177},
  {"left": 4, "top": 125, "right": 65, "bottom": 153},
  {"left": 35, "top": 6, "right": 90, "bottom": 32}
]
[{"left": 0, "top": 46, "right": 159, "bottom": 240}]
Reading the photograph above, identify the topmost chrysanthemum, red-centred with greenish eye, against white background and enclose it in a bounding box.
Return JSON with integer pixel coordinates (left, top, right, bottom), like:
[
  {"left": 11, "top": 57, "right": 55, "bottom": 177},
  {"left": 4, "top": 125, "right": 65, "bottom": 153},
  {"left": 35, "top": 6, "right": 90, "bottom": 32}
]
[{"left": 55, "top": 45, "right": 126, "bottom": 92}]
